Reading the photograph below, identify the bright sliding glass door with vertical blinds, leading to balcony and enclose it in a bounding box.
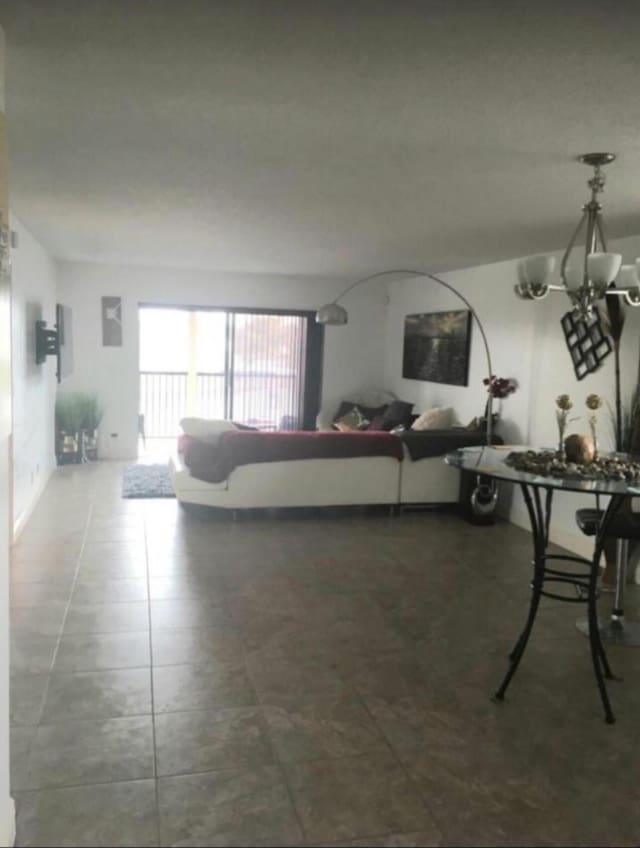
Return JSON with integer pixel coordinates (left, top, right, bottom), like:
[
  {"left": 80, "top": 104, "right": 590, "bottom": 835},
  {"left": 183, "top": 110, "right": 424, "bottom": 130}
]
[{"left": 140, "top": 305, "right": 322, "bottom": 438}]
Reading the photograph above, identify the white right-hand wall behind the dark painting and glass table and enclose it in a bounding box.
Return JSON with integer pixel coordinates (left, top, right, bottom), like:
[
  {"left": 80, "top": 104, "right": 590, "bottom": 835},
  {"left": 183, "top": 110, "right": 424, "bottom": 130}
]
[{"left": 385, "top": 237, "right": 640, "bottom": 552}]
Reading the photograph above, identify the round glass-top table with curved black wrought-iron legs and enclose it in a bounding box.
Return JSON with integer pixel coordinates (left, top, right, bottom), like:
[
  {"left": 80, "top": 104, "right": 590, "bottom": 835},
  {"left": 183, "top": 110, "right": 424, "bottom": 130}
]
[{"left": 445, "top": 445, "right": 640, "bottom": 724}]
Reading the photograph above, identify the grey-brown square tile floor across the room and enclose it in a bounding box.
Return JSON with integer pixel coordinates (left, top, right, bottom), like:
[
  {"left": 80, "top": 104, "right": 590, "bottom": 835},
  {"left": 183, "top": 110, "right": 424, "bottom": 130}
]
[{"left": 11, "top": 463, "right": 640, "bottom": 846}]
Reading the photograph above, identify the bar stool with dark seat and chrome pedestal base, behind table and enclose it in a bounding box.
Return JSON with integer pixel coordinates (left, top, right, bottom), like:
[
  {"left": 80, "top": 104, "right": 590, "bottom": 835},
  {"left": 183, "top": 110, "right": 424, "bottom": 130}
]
[{"left": 576, "top": 509, "right": 640, "bottom": 648}]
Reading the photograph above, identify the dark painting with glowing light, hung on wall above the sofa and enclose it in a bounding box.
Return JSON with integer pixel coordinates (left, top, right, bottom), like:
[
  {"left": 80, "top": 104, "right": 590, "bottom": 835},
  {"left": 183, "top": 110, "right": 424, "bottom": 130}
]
[{"left": 402, "top": 309, "right": 471, "bottom": 386}]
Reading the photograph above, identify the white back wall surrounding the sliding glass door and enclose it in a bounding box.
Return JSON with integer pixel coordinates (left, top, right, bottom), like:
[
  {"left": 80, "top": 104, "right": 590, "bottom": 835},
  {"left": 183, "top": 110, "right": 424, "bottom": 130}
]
[{"left": 58, "top": 262, "right": 384, "bottom": 459}]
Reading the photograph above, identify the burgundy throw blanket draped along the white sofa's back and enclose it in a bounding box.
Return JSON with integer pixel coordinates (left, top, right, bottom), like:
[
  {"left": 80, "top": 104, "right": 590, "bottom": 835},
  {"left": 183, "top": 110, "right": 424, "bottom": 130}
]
[{"left": 180, "top": 430, "right": 403, "bottom": 483}]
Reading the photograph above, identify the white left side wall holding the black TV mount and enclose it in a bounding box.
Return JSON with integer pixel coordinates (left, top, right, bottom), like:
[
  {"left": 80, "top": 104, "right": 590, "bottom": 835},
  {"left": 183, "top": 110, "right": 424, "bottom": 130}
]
[{"left": 11, "top": 216, "right": 56, "bottom": 535}]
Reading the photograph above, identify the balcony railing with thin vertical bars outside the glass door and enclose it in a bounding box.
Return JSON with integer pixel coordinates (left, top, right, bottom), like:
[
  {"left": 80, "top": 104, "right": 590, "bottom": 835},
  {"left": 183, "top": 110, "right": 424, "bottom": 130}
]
[{"left": 140, "top": 371, "right": 300, "bottom": 438}]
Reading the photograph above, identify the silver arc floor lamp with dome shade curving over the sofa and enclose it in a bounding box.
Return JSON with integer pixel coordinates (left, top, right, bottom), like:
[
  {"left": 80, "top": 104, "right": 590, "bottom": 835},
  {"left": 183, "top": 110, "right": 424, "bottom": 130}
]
[{"left": 316, "top": 268, "right": 498, "bottom": 515}]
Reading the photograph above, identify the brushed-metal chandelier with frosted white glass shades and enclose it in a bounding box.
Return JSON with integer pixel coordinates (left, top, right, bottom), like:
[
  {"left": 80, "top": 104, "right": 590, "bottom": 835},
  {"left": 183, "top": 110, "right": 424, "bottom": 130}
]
[{"left": 515, "top": 153, "right": 640, "bottom": 321}]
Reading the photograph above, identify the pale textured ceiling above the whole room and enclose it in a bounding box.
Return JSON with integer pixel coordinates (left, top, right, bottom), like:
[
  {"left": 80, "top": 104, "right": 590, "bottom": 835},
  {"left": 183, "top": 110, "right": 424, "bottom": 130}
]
[{"left": 0, "top": 0, "right": 640, "bottom": 278}]
